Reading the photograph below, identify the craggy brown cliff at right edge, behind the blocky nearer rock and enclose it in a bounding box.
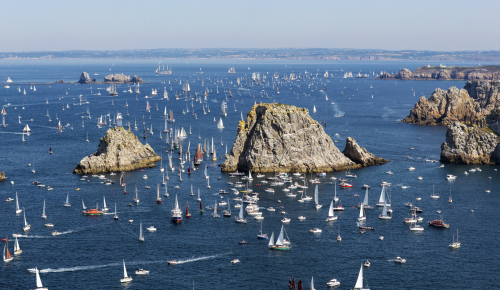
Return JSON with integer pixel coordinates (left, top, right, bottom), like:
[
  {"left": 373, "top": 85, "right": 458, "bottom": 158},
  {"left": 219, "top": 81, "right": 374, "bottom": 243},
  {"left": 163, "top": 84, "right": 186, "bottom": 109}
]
[{"left": 403, "top": 81, "right": 500, "bottom": 127}]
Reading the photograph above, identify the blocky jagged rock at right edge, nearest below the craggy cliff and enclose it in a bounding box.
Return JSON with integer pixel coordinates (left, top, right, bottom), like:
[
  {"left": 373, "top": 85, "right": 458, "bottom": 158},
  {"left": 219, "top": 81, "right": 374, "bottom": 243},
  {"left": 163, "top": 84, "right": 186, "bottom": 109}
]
[{"left": 441, "top": 122, "right": 500, "bottom": 164}]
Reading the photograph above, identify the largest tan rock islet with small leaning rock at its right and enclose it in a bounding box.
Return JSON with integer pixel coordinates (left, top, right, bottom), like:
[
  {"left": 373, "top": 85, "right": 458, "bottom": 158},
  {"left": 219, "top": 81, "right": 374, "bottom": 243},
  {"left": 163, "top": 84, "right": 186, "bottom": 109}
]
[{"left": 221, "top": 104, "right": 386, "bottom": 172}]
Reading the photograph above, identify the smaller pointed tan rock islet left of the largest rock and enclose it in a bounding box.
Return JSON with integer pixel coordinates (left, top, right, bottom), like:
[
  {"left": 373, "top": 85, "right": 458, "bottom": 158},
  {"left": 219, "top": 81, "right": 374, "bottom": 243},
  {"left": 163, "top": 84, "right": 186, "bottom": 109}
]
[{"left": 73, "top": 127, "right": 161, "bottom": 174}]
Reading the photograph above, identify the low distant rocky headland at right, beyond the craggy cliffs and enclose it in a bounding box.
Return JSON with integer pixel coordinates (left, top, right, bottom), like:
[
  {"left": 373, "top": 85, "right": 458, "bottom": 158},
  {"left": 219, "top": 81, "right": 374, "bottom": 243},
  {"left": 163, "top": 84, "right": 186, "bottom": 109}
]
[{"left": 377, "top": 65, "right": 500, "bottom": 81}]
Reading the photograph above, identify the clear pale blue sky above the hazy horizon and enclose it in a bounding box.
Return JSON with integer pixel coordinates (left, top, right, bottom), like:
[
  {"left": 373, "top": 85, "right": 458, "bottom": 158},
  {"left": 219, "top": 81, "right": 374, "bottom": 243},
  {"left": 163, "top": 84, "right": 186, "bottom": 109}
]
[{"left": 0, "top": 0, "right": 500, "bottom": 52}]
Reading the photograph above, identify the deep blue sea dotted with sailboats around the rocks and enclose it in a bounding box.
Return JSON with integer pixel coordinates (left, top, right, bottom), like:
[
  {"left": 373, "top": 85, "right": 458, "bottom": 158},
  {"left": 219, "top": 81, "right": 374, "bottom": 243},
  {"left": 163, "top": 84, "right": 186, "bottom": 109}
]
[{"left": 0, "top": 59, "right": 500, "bottom": 290}]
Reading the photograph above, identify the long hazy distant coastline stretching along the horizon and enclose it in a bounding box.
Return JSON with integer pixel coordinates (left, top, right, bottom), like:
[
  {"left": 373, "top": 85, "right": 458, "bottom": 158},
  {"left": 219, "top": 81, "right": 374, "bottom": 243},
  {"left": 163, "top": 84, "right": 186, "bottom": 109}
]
[{"left": 0, "top": 48, "right": 500, "bottom": 62}]
